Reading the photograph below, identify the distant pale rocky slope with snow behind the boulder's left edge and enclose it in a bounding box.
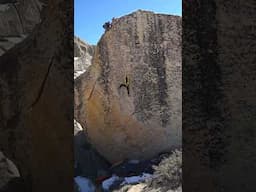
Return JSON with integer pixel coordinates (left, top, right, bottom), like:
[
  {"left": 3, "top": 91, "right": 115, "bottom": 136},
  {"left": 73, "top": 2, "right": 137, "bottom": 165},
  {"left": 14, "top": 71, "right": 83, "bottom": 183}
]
[{"left": 74, "top": 37, "right": 95, "bottom": 78}]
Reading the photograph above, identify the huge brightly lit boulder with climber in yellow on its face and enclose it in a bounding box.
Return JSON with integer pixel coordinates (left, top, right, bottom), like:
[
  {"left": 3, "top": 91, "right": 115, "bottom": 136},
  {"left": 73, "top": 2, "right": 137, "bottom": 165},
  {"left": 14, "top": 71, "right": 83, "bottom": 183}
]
[{"left": 75, "top": 10, "right": 182, "bottom": 162}]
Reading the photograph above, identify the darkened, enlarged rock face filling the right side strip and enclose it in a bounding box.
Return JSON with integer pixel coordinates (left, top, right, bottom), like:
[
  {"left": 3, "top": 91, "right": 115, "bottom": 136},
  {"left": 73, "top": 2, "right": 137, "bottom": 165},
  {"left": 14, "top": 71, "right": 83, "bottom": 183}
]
[{"left": 182, "top": 0, "right": 256, "bottom": 192}]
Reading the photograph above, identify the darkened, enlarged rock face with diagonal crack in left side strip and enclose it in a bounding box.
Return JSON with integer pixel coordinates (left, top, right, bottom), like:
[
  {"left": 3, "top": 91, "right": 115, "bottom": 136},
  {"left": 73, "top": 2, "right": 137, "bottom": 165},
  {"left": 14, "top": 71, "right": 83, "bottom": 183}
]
[{"left": 0, "top": 0, "right": 74, "bottom": 192}]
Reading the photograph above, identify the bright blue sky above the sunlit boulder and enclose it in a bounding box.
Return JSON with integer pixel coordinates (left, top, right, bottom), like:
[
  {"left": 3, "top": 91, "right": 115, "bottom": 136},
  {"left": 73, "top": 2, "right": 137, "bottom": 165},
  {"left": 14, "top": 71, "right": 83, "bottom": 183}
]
[{"left": 74, "top": 0, "right": 182, "bottom": 44}]
